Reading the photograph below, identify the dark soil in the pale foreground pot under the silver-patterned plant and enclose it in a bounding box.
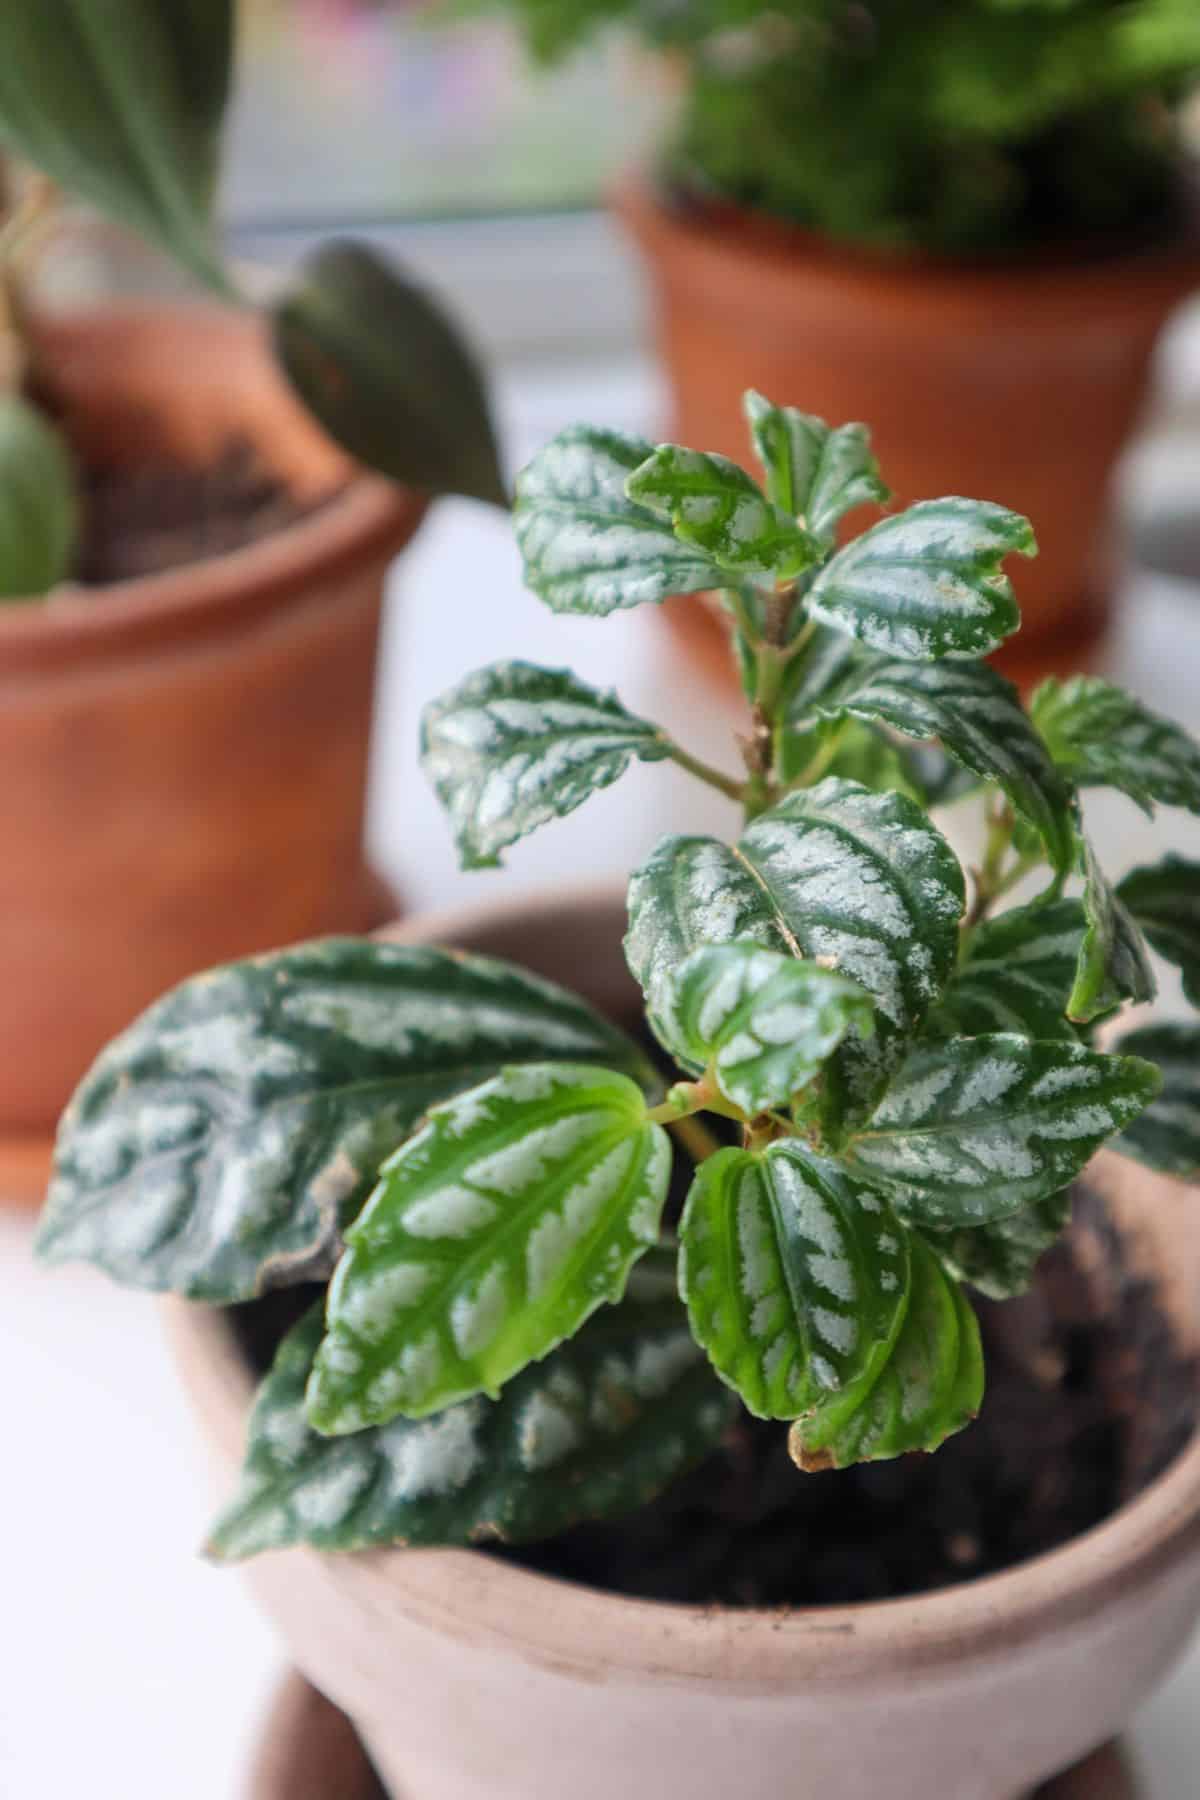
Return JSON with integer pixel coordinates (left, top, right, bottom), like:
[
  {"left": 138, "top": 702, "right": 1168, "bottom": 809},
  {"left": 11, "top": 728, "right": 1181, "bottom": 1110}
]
[{"left": 234, "top": 1184, "right": 1196, "bottom": 1606}]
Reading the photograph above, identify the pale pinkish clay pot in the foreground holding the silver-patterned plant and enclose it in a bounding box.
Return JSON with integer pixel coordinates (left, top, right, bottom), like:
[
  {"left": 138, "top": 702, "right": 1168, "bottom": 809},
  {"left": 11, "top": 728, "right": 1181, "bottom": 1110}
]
[{"left": 167, "top": 896, "right": 1200, "bottom": 1800}]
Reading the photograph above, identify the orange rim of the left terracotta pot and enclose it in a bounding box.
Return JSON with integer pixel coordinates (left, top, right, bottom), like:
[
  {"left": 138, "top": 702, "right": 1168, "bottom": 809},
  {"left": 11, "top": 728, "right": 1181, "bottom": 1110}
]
[{"left": 0, "top": 301, "right": 430, "bottom": 675}]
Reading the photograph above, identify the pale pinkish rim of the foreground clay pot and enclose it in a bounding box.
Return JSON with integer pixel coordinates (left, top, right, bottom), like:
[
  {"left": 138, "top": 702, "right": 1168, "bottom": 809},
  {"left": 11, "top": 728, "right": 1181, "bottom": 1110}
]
[{"left": 166, "top": 884, "right": 1200, "bottom": 1694}]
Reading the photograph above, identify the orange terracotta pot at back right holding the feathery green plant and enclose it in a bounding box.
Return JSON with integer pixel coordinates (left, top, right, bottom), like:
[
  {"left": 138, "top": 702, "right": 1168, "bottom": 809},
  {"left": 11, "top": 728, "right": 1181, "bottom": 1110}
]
[{"left": 615, "top": 182, "right": 1200, "bottom": 677}]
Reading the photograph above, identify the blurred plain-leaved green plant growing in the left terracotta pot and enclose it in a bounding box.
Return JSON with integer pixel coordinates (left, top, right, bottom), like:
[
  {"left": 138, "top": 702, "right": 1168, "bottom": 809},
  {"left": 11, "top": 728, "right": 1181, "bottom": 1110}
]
[{"left": 0, "top": 0, "right": 507, "bottom": 599}]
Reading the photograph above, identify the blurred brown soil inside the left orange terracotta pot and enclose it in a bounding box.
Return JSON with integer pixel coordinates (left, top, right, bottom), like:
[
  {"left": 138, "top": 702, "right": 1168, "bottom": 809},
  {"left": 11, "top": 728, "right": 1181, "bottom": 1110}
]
[{"left": 76, "top": 439, "right": 338, "bottom": 587}]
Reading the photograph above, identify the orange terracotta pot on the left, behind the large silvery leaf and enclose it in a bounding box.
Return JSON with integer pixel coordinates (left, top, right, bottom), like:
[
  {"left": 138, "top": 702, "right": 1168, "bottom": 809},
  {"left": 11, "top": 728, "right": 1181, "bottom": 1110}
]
[{"left": 0, "top": 306, "right": 425, "bottom": 1199}]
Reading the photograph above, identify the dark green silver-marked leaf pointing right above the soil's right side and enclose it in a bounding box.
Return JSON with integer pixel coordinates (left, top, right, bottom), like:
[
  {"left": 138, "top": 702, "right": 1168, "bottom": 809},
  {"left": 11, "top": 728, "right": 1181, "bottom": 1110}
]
[{"left": 846, "top": 1031, "right": 1160, "bottom": 1228}]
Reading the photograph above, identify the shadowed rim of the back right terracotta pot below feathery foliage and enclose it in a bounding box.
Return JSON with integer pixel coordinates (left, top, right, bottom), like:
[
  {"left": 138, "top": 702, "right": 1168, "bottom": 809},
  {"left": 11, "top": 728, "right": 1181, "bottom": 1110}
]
[{"left": 610, "top": 169, "right": 1200, "bottom": 310}]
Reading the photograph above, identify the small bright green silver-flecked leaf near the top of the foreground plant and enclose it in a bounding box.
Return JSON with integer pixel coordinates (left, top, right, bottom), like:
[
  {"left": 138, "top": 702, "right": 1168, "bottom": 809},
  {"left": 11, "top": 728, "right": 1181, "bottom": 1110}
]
[{"left": 624, "top": 445, "right": 817, "bottom": 580}]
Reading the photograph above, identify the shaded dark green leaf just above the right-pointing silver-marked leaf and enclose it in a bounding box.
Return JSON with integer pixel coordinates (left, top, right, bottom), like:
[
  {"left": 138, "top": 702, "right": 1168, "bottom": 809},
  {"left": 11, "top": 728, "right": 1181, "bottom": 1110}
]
[{"left": 927, "top": 900, "right": 1087, "bottom": 1042}]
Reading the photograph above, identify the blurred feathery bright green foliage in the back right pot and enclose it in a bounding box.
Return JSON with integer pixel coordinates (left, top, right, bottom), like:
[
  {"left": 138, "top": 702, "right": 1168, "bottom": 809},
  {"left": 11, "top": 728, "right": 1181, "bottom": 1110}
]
[{"left": 475, "top": 0, "right": 1200, "bottom": 254}]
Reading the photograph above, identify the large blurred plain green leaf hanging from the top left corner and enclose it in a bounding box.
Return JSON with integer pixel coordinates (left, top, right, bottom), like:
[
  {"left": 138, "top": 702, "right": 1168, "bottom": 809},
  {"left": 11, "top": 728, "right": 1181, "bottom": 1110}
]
[{"left": 0, "top": 0, "right": 234, "bottom": 288}]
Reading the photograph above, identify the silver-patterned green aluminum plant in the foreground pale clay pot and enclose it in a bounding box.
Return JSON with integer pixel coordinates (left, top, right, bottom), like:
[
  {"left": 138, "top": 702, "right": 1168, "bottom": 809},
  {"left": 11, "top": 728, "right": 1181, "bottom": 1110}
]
[{"left": 41, "top": 394, "right": 1200, "bottom": 1557}]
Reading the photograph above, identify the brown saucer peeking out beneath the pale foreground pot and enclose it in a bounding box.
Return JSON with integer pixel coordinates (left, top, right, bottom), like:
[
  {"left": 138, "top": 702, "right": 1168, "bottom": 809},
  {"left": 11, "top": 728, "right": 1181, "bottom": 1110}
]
[{"left": 243, "top": 1672, "right": 1139, "bottom": 1800}]
